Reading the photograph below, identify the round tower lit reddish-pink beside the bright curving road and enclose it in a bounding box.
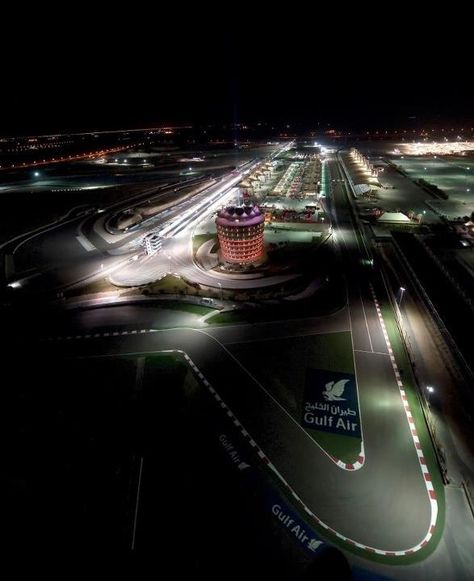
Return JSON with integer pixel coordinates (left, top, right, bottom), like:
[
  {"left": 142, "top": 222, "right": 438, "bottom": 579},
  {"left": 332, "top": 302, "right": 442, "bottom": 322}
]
[{"left": 216, "top": 204, "right": 264, "bottom": 264}]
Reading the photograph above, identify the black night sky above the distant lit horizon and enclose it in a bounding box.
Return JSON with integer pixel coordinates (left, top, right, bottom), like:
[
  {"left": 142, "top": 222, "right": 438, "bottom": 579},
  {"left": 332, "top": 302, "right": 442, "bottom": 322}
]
[{"left": 0, "top": 10, "right": 473, "bottom": 135}]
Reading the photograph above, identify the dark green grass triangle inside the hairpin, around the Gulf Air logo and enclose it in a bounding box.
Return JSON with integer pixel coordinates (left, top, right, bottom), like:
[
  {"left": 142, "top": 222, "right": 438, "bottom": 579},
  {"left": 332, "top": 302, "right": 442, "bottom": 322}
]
[{"left": 231, "top": 331, "right": 361, "bottom": 463}]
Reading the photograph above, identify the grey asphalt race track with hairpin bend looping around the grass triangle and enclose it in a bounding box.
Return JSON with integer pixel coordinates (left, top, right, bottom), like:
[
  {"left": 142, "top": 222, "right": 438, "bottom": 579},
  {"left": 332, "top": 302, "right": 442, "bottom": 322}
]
[{"left": 32, "top": 153, "right": 431, "bottom": 551}]
